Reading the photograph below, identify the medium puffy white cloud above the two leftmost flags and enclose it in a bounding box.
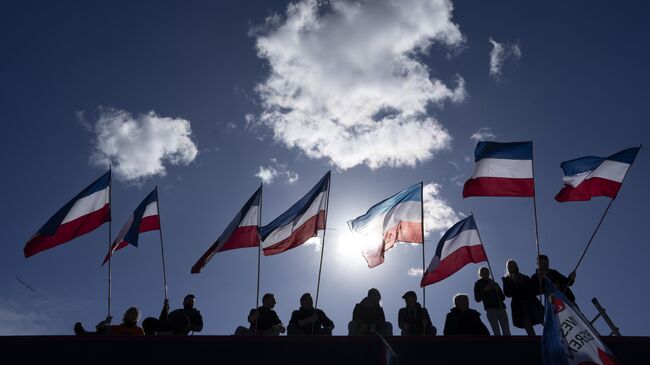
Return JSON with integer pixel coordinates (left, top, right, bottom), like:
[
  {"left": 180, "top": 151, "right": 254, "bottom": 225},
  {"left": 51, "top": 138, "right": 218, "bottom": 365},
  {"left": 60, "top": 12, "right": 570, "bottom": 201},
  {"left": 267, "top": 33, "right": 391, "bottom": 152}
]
[{"left": 90, "top": 108, "right": 198, "bottom": 181}]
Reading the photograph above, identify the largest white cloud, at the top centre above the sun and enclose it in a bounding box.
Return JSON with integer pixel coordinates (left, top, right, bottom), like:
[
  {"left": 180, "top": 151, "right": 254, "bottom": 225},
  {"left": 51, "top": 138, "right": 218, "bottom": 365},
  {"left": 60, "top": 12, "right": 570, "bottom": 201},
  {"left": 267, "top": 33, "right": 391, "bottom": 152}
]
[{"left": 252, "top": 0, "right": 465, "bottom": 169}]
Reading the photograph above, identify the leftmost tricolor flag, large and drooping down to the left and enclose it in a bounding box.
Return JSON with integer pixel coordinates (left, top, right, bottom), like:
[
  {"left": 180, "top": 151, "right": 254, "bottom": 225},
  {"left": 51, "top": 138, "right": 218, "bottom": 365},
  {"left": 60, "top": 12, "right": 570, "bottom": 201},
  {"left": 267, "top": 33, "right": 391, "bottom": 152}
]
[{"left": 23, "top": 171, "right": 111, "bottom": 258}]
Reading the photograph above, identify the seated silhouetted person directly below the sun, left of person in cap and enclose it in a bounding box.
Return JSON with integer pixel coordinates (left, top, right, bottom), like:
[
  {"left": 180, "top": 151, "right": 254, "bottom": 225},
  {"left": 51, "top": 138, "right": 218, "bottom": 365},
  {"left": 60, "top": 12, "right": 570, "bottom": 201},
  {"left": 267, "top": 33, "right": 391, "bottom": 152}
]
[{"left": 348, "top": 288, "right": 393, "bottom": 336}]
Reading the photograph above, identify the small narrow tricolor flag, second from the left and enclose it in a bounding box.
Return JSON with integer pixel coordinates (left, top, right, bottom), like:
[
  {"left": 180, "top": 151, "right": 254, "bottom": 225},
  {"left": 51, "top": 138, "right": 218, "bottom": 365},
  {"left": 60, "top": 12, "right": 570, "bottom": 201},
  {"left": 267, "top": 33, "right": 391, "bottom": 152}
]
[{"left": 102, "top": 188, "right": 160, "bottom": 266}]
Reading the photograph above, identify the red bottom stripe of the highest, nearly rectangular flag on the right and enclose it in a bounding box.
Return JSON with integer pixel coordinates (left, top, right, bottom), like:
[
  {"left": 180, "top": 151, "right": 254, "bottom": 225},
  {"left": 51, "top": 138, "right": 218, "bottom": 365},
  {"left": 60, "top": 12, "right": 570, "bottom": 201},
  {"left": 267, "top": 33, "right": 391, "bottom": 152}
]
[{"left": 463, "top": 177, "right": 535, "bottom": 198}]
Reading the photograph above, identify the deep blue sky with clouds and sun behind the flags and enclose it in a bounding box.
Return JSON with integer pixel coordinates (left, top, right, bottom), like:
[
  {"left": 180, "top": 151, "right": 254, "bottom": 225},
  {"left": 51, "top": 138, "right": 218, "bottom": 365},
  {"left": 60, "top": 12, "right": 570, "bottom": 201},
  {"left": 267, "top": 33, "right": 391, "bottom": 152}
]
[{"left": 0, "top": 0, "right": 650, "bottom": 335}]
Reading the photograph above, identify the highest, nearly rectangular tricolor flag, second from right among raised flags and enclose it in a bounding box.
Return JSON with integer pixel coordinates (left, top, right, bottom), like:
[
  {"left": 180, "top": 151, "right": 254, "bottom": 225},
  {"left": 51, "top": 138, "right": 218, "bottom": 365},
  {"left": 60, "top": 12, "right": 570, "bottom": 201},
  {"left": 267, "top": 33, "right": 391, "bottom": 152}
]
[{"left": 463, "top": 142, "right": 535, "bottom": 198}]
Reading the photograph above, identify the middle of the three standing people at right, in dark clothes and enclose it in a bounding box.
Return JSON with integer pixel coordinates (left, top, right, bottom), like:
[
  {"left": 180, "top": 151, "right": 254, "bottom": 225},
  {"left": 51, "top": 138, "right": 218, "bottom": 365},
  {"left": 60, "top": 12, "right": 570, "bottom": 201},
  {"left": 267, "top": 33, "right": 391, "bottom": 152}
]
[{"left": 502, "top": 260, "right": 544, "bottom": 336}]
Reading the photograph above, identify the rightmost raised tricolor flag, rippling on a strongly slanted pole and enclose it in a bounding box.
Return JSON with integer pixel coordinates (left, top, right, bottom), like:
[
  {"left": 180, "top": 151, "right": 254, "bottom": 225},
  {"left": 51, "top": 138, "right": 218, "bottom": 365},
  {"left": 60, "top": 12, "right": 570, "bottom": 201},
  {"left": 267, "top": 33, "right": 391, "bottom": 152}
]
[{"left": 555, "top": 147, "right": 639, "bottom": 202}]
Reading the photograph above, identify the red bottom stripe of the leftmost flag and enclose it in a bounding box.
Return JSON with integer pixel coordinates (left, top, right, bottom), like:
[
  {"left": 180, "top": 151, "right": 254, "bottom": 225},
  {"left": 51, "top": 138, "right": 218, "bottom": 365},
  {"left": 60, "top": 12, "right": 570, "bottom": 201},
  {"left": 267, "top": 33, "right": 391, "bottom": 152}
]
[{"left": 23, "top": 204, "right": 111, "bottom": 258}]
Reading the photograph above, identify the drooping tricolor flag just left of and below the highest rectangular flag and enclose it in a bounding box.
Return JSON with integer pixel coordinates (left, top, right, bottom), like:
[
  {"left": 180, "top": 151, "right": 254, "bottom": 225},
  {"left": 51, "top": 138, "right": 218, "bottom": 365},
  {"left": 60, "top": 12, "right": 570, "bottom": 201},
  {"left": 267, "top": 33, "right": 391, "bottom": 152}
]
[{"left": 420, "top": 215, "right": 487, "bottom": 287}]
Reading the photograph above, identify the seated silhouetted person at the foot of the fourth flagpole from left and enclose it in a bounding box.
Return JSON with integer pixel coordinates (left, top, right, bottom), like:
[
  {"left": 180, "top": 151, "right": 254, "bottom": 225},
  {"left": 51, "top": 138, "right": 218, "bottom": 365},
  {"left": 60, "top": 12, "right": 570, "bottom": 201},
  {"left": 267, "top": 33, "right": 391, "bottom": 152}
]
[{"left": 287, "top": 293, "right": 334, "bottom": 336}]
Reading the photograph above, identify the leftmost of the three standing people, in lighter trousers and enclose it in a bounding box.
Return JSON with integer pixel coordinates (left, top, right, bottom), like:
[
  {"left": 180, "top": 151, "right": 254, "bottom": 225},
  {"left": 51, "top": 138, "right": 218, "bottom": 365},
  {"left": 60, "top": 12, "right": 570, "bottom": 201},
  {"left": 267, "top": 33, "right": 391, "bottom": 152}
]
[{"left": 474, "top": 266, "right": 510, "bottom": 336}]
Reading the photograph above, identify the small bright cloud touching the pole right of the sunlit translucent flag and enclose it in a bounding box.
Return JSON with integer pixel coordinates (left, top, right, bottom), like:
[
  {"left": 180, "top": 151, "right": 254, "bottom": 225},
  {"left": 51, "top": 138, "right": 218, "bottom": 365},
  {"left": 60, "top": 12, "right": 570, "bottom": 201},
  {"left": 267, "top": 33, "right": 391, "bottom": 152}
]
[{"left": 423, "top": 182, "right": 459, "bottom": 236}]
